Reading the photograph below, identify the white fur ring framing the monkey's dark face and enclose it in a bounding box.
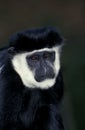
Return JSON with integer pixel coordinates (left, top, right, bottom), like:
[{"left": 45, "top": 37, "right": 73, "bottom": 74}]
[{"left": 12, "top": 46, "right": 60, "bottom": 89}]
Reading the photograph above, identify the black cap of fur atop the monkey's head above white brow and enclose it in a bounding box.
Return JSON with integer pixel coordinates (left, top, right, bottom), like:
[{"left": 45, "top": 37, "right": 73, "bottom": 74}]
[{"left": 10, "top": 27, "right": 63, "bottom": 51}]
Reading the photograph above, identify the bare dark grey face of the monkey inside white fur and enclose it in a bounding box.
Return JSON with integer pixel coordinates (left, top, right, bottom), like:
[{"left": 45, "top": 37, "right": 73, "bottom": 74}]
[{"left": 26, "top": 51, "right": 55, "bottom": 82}]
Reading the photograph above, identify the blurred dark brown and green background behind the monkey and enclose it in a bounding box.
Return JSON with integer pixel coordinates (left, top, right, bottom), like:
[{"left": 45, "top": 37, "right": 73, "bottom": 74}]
[{"left": 0, "top": 0, "right": 85, "bottom": 130}]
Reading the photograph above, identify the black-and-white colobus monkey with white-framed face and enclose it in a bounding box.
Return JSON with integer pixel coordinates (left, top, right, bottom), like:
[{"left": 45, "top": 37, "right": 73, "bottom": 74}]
[{"left": 0, "top": 27, "right": 64, "bottom": 130}]
